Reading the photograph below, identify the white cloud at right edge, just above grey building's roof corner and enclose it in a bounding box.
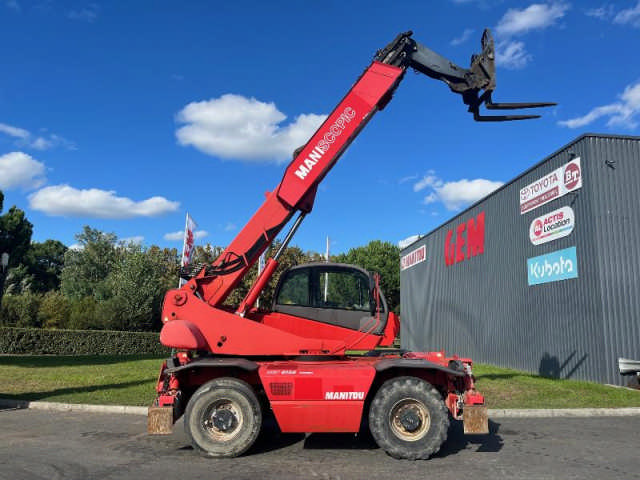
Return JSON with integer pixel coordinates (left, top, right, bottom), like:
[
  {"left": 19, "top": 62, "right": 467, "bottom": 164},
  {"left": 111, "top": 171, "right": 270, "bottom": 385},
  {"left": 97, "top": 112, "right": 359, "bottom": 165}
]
[{"left": 558, "top": 81, "right": 640, "bottom": 129}]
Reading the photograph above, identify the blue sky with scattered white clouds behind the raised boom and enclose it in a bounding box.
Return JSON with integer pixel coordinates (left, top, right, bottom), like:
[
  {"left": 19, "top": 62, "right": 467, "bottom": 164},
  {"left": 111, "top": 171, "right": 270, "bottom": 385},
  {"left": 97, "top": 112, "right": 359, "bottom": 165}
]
[{"left": 0, "top": 0, "right": 640, "bottom": 253}]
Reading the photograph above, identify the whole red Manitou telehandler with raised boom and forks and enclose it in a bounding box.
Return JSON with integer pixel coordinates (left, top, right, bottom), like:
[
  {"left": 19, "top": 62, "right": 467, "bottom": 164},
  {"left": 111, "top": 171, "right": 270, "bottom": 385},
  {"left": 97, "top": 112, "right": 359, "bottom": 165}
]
[{"left": 148, "top": 30, "right": 553, "bottom": 459}]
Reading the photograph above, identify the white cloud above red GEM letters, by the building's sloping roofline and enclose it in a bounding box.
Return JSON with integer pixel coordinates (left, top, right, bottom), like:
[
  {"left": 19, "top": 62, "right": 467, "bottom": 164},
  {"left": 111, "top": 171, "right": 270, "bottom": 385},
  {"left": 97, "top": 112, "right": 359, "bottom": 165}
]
[{"left": 413, "top": 175, "right": 503, "bottom": 210}]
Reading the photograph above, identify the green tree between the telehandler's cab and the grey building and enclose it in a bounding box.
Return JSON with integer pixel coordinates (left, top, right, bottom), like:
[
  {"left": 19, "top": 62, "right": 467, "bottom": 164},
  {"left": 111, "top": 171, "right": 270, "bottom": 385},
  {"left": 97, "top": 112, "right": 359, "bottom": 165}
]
[{"left": 332, "top": 240, "right": 400, "bottom": 312}]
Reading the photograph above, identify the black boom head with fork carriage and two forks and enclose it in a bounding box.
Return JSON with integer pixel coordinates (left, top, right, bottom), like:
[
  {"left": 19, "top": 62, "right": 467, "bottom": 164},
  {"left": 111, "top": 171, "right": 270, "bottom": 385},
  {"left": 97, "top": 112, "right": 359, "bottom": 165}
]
[{"left": 374, "top": 28, "right": 556, "bottom": 122}]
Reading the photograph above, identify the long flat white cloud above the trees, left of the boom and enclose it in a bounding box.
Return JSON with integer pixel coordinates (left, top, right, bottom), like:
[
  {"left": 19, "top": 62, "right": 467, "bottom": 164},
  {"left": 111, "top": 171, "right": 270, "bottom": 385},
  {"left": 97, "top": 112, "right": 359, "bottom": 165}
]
[{"left": 29, "top": 185, "right": 180, "bottom": 219}]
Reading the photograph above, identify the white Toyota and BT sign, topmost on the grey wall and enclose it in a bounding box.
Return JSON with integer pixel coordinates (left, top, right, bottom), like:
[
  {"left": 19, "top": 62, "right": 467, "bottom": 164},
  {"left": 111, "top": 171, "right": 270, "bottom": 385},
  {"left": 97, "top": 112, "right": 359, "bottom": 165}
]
[{"left": 520, "top": 158, "right": 582, "bottom": 214}]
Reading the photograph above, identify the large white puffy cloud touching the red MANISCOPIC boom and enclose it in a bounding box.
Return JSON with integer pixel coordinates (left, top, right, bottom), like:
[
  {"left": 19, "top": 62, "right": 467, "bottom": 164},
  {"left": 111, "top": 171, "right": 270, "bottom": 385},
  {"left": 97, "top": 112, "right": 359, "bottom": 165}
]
[{"left": 176, "top": 94, "right": 326, "bottom": 163}]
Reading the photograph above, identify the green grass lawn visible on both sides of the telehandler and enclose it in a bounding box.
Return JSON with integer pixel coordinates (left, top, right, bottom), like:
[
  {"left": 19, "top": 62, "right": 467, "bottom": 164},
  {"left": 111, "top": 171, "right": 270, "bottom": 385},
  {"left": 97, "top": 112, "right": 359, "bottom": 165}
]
[{"left": 0, "top": 355, "right": 640, "bottom": 408}]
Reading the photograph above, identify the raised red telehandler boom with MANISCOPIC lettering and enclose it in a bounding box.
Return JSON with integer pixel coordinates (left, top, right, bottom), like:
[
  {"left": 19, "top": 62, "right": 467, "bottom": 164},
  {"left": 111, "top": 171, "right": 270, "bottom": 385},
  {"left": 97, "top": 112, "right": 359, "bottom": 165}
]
[{"left": 198, "top": 62, "right": 404, "bottom": 306}]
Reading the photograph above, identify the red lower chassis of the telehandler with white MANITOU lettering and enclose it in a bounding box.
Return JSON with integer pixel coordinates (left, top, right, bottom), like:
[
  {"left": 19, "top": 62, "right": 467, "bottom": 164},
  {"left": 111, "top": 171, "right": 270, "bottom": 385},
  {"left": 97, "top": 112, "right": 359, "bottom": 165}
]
[{"left": 157, "top": 352, "right": 486, "bottom": 433}]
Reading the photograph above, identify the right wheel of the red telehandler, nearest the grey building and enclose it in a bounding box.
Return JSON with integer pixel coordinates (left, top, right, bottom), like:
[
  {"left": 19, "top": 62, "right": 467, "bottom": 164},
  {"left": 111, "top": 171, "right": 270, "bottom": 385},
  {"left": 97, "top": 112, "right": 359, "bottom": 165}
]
[{"left": 369, "top": 377, "right": 449, "bottom": 460}]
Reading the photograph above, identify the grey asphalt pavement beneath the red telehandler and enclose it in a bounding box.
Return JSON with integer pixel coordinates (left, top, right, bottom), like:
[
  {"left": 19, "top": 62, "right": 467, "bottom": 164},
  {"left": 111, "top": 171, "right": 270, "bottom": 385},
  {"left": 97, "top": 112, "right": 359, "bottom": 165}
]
[{"left": 0, "top": 409, "right": 640, "bottom": 480}]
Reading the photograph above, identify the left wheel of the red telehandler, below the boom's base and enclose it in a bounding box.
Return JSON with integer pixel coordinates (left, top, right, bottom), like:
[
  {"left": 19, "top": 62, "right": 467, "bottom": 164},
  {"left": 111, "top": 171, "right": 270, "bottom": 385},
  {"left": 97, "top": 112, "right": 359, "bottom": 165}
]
[{"left": 184, "top": 377, "right": 262, "bottom": 457}]
